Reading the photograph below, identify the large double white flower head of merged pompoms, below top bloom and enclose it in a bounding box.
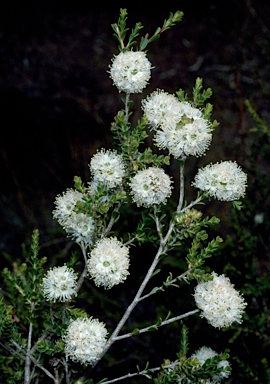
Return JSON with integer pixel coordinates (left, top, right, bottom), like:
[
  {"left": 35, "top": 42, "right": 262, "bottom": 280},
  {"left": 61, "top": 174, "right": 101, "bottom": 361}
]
[{"left": 142, "top": 90, "right": 212, "bottom": 158}]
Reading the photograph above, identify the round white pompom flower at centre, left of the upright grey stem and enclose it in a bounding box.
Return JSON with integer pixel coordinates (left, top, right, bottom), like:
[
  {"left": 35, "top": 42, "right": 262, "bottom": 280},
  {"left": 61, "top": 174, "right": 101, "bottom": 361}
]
[{"left": 129, "top": 167, "right": 172, "bottom": 207}]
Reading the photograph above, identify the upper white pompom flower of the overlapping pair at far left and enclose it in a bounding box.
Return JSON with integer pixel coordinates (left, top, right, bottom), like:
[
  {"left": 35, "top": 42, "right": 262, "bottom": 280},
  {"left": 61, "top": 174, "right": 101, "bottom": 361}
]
[{"left": 53, "top": 188, "right": 83, "bottom": 225}]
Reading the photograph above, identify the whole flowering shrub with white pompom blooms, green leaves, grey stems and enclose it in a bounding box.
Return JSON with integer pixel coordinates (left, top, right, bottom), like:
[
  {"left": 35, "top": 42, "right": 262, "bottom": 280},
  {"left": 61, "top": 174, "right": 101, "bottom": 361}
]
[{"left": 0, "top": 9, "right": 247, "bottom": 384}]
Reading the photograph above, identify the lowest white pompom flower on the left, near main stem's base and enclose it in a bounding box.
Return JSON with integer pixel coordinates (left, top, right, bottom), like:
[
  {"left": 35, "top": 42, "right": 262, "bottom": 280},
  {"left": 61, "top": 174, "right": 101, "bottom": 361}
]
[{"left": 63, "top": 317, "right": 108, "bottom": 364}]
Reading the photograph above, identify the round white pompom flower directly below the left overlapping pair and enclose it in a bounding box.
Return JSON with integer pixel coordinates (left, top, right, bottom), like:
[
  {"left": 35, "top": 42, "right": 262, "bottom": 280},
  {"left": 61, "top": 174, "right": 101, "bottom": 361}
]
[{"left": 87, "top": 237, "right": 129, "bottom": 289}]
